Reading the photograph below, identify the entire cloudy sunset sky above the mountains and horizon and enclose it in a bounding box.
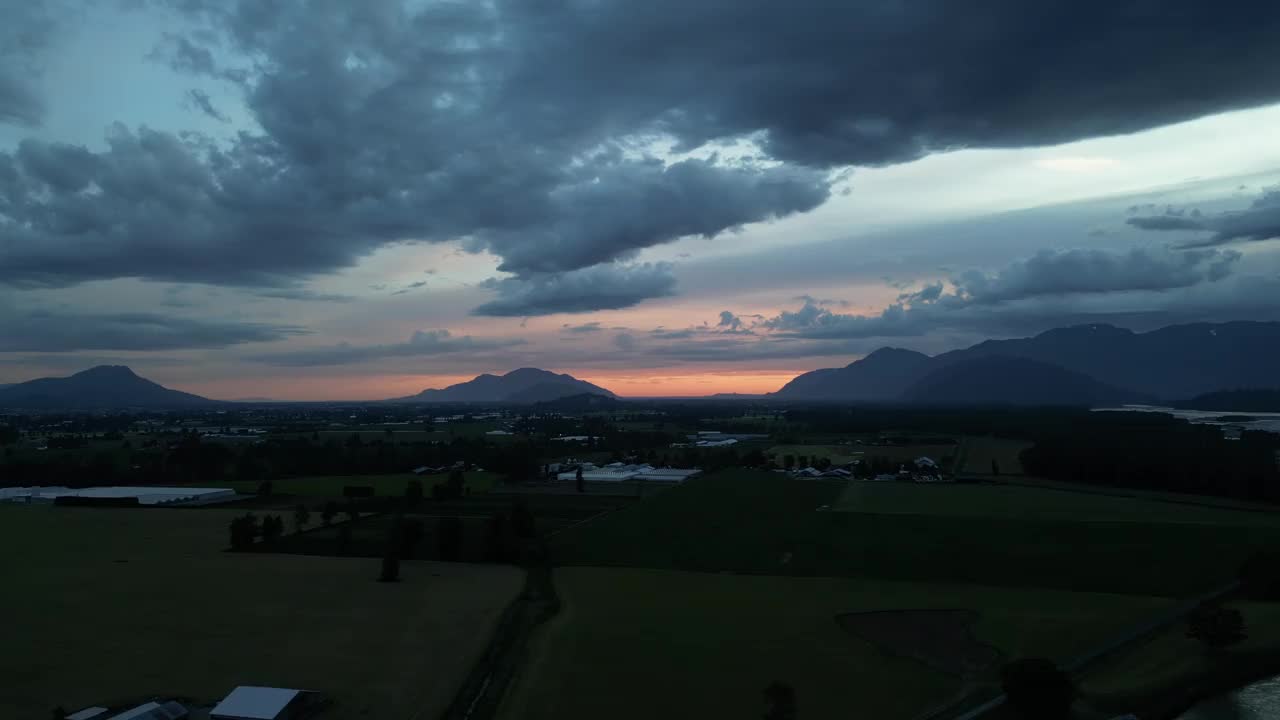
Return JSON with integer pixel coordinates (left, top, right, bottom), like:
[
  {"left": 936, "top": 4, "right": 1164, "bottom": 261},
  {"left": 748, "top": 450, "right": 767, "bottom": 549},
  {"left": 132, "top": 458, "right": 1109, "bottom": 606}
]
[{"left": 0, "top": 0, "right": 1280, "bottom": 400}]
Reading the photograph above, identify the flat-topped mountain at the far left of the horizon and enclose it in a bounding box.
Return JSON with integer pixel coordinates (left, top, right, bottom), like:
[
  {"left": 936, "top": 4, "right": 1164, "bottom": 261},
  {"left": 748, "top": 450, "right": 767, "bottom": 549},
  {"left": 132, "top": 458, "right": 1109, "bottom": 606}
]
[{"left": 0, "top": 365, "right": 220, "bottom": 410}]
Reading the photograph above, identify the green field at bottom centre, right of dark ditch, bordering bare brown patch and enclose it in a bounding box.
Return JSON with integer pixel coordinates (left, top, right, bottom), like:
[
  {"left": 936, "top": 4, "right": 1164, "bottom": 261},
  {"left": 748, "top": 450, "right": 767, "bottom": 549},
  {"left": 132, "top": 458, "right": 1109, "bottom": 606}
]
[{"left": 500, "top": 568, "right": 1167, "bottom": 720}]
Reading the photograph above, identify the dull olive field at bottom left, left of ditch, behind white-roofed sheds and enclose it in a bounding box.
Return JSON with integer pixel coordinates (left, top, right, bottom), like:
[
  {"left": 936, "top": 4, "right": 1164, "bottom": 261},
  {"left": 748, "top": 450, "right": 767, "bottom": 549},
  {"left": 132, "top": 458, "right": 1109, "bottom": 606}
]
[{"left": 0, "top": 506, "right": 522, "bottom": 719}]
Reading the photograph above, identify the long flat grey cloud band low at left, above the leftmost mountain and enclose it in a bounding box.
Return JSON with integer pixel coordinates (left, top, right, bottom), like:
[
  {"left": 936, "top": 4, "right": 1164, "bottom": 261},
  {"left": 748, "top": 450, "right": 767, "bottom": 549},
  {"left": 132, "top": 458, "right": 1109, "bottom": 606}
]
[{"left": 0, "top": 311, "right": 306, "bottom": 352}]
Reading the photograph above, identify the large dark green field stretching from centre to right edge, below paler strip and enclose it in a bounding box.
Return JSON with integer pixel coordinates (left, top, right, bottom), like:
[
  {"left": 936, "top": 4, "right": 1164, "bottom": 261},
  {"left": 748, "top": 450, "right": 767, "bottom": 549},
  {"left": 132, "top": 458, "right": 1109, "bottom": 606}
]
[{"left": 552, "top": 470, "right": 1280, "bottom": 597}]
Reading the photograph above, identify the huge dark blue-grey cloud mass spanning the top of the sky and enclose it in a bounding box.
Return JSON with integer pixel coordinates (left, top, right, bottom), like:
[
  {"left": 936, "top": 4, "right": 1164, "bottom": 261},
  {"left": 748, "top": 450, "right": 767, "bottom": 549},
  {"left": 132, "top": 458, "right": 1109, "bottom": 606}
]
[{"left": 0, "top": 0, "right": 1280, "bottom": 313}]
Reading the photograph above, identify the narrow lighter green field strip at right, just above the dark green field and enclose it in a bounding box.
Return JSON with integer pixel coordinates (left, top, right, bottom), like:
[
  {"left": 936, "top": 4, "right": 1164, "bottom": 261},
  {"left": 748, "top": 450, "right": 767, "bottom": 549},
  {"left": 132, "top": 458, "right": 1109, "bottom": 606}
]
[{"left": 832, "top": 482, "right": 1280, "bottom": 528}]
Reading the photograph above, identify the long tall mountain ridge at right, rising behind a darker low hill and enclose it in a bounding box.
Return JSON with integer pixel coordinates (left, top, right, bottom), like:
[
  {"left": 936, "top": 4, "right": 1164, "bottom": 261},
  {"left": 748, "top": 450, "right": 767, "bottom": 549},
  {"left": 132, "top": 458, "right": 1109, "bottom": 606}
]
[{"left": 773, "top": 322, "right": 1280, "bottom": 404}]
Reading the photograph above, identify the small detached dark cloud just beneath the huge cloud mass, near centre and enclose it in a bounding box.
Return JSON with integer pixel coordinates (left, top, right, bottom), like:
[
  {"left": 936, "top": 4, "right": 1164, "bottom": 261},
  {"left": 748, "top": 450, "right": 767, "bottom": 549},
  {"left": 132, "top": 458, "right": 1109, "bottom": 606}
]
[{"left": 474, "top": 263, "right": 676, "bottom": 318}]
